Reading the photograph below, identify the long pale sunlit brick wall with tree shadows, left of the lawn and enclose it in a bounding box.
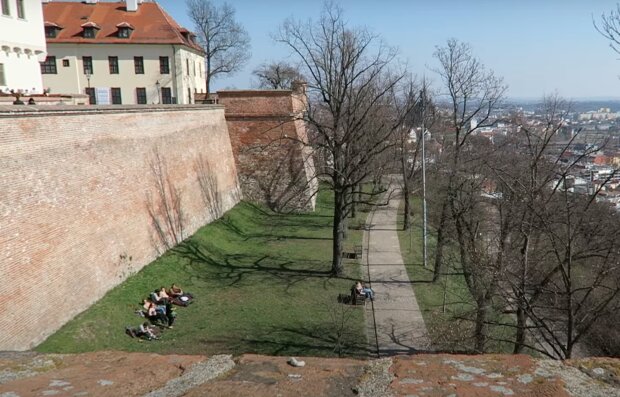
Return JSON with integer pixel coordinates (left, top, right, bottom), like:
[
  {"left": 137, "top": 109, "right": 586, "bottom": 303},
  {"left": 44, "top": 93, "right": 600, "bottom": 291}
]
[{"left": 0, "top": 106, "right": 239, "bottom": 350}]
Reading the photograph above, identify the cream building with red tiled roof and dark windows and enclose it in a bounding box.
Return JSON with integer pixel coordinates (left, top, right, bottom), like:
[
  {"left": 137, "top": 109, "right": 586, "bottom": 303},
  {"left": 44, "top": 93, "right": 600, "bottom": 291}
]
[{"left": 42, "top": 0, "right": 206, "bottom": 104}]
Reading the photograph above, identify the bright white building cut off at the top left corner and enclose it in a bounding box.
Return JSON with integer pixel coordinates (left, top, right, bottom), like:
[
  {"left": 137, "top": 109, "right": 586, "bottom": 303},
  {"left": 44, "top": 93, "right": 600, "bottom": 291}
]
[{"left": 0, "top": 0, "right": 45, "bottom": 94}]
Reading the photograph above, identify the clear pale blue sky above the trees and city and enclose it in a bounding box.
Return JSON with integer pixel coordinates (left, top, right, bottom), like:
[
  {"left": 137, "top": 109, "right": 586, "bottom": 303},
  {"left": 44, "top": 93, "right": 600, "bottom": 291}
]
[{"left": 157, "top": 0, "right": 620, "bottom": 99}]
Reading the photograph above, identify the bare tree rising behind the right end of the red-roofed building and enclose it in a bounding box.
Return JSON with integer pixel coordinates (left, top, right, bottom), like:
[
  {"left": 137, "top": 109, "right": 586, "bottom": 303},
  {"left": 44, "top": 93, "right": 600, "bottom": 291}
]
[{"left": 187, "top": 0, "right": 250, "bottom": 94}]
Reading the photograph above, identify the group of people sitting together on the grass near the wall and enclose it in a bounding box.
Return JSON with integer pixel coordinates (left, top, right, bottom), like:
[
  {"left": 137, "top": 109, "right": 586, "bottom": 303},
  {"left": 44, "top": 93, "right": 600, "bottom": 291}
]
[{"left": 125, "top": 284, "right": 194, "bottom": 340}]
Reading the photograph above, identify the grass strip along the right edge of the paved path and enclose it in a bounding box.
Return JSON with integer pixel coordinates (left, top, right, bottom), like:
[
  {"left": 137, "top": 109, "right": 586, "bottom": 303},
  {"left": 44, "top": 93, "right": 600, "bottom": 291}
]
[{"left": 398, "top": 197, "right": 514, "bottom": 353}]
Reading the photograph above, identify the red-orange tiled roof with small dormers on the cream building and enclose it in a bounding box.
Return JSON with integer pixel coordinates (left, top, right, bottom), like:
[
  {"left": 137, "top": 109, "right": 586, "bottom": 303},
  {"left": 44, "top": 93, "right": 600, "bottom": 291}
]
[{"left": 43, "top": 1, "right": 202, "bottom": 52}]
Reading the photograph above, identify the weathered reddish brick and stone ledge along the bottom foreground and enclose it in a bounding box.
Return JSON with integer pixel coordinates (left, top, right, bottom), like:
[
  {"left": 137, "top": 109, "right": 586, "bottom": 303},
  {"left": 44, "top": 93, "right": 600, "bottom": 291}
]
[{"left": 0, "top": 352, "right": 620, "bottom": 397}]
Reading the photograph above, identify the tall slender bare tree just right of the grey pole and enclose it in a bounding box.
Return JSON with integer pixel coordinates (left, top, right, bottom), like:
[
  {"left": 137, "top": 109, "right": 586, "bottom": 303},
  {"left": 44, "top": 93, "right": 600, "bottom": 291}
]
[{"left": 433, "top": 39, "right": 506, "bottom": 281}]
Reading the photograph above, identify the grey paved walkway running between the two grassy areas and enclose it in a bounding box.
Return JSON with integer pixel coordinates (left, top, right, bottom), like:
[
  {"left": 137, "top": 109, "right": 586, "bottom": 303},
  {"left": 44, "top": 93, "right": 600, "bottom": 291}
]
[{"left": 363, "top": 178, "right": 430, "bottom": 356}]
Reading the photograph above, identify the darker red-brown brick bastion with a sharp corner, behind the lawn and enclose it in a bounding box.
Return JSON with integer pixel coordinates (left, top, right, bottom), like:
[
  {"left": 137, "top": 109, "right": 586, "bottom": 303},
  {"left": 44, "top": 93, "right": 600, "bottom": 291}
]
[{"left": 217, "top": 90, "right": 317, "bottom": 211}]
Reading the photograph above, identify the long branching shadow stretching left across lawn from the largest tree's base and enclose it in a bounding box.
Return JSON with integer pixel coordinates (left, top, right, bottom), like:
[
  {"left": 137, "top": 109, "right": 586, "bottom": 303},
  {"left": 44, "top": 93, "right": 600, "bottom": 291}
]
[{"left": 173, "top": 240, "right": 353, "bottom": 290}]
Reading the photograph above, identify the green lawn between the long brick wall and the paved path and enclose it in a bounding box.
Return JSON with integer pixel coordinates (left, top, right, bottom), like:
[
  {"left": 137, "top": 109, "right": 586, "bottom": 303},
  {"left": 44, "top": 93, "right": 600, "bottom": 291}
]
[{"left": 36, "top": 187, "right": 366, "bottom": 356}]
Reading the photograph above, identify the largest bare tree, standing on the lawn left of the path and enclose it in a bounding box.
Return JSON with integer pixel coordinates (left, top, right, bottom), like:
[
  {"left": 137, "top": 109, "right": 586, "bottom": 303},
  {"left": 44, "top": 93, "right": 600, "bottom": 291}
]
[{"left": 276, "top": 5, "right": 410, "bottom": 274}]
